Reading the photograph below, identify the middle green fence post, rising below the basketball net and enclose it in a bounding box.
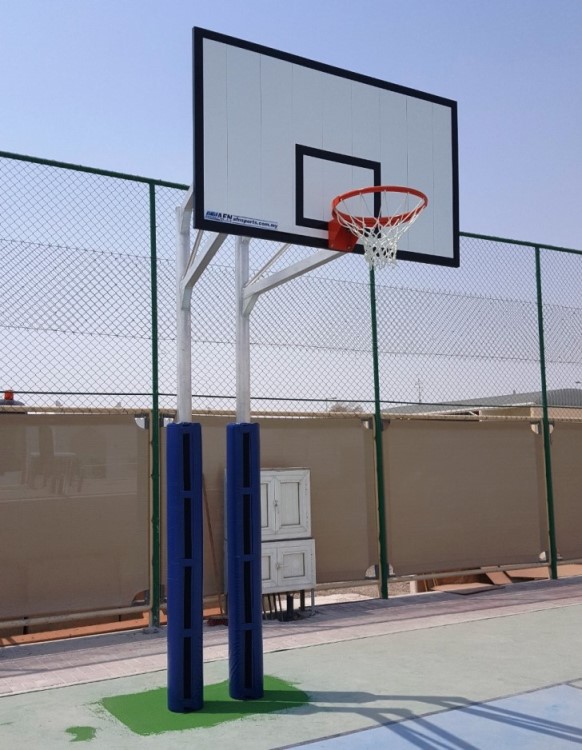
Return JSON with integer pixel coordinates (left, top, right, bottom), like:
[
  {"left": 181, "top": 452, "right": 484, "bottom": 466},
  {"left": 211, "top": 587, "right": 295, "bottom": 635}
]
[{"left": 370, "top": 268, "right": 388, "bottom": 599}]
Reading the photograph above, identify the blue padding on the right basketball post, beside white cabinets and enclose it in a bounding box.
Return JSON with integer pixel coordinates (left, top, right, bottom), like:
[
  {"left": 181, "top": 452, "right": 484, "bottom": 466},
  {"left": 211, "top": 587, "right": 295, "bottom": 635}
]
[{"left": 226, "top": 424, "right": 263, "bottom": 700}]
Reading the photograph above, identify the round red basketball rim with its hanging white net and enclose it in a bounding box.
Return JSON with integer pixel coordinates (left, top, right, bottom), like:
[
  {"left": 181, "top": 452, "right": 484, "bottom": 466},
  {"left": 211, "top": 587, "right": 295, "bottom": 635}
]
[{"left": 335, "top": 189, "right": 426, "bottom": 268}]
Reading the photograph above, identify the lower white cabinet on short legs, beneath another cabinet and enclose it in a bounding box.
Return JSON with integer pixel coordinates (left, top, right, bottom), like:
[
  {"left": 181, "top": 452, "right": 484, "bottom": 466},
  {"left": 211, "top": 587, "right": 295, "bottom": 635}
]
[{"left": 261, "top": 539, "right": 315, "bottom": 594}]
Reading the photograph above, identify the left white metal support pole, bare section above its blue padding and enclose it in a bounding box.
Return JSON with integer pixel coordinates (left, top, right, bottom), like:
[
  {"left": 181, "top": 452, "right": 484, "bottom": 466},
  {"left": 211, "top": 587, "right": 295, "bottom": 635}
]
[{"left": 176, "top": 206, "right": 192, "bottom": 422}]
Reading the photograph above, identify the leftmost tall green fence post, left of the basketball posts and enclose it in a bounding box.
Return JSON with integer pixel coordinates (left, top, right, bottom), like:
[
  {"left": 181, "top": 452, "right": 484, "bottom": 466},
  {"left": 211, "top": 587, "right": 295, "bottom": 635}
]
[{"left": 149, "top": 182, "right": 161, "bottom": 628}]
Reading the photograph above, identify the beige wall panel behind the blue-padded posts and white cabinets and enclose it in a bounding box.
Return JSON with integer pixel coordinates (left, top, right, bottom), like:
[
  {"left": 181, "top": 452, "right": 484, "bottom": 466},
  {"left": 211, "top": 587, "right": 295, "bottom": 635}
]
[{"left": 163, "top": 417, "right": 377, "bottom": 596}]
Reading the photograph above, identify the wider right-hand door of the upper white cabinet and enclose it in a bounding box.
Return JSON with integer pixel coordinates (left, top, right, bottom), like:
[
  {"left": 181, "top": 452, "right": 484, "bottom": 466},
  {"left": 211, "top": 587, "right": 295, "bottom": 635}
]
[{"left": 274, "top": 470, "right": 311, "bottom": 539}]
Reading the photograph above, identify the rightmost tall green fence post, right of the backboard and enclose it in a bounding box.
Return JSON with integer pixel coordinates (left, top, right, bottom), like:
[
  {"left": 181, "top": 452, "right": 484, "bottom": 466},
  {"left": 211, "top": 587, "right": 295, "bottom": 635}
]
[{"left": 535, "top": 246, "right": 558, "bottom": 580}]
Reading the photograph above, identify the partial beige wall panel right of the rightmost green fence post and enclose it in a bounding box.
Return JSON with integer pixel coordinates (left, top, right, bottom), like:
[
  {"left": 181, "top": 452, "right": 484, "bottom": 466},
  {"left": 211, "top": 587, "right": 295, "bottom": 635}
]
[{"left": 552, "top": 423, "right": 582, "bottom": 560}]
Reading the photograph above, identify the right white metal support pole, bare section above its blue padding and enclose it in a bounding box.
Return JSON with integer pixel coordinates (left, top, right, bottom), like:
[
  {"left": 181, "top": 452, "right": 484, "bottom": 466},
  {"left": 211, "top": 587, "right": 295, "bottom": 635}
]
[{"left": 235, "top": 237, "right": 251, "bottom": 424}]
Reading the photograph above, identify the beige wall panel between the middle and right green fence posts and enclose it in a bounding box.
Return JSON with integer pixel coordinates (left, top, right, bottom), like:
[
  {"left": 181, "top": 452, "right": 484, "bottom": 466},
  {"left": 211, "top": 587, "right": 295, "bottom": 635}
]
[{"left": 384, "top": 420, "right": 547, "bottom": 575}]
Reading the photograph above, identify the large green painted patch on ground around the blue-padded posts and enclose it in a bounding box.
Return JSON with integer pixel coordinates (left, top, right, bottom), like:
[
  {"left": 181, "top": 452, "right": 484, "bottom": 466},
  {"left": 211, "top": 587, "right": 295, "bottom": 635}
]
[{"left": 99, "top": 676, "right": 309, "bottom": 735}]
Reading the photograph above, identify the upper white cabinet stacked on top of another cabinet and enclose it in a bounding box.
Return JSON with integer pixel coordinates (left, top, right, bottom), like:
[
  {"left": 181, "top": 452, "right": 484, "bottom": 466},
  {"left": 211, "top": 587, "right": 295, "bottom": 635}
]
[{"left": 261, "top": 469, "right": 311, "bottom": 542}]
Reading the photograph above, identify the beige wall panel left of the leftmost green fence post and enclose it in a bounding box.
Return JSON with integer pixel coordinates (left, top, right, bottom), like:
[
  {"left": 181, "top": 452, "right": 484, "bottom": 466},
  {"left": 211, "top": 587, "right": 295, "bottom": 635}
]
[{"left": 0, "top": 414, "right": 150, "bottom": 619}]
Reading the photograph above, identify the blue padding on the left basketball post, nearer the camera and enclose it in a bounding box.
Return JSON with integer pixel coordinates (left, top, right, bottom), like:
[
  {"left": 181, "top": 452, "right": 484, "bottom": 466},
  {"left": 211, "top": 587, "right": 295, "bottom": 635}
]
[{"left": 166, "top": 422, "right": 204, "bottom": 713}]
